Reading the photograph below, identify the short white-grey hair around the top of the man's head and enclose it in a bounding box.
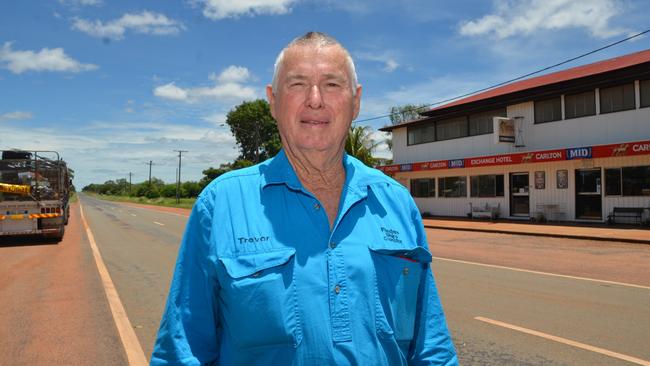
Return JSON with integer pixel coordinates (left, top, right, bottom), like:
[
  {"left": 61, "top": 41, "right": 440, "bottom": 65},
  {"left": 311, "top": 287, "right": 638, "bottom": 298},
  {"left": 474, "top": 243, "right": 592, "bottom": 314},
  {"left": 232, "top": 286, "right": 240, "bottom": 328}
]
[{"left": 271, "top": 32, "right": 359, "bottom": 96}]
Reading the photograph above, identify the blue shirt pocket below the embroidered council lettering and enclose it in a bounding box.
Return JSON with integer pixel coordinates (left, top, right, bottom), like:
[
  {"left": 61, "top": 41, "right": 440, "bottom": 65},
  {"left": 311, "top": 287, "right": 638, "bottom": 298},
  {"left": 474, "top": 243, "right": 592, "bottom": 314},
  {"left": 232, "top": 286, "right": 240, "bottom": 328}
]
[{"left": 369, "top": 243, "right": 431, "bottom": 348}]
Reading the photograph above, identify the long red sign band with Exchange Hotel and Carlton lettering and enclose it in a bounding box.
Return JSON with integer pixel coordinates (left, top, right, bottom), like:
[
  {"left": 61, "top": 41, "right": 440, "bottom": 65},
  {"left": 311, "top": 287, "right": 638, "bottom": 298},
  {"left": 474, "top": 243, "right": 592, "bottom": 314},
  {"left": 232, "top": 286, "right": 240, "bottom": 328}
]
[{"left": 377, "top": 141, "right": 650, "bottom": 174}]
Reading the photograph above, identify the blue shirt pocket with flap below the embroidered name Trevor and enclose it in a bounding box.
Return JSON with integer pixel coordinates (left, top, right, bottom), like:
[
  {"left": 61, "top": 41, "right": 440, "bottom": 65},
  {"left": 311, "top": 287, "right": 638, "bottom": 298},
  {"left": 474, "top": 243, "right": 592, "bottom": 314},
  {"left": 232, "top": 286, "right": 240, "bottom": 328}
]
[{"left": 219, "top": 248, "right": 302, "bottom": 348}]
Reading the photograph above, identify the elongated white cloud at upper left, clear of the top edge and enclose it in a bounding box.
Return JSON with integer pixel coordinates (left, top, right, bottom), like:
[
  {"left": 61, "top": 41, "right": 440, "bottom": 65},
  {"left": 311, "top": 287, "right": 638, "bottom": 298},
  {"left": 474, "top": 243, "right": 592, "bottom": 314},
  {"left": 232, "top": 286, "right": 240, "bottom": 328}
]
[{"left": 72, "top": 11, "right": 185, "bottom": 40}]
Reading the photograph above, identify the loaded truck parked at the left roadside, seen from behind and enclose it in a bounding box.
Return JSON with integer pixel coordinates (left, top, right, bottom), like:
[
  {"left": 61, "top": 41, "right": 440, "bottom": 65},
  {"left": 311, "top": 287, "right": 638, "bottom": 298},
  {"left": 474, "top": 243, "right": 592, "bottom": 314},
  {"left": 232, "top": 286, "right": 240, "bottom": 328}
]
[{"left": 0, "top": 150, "right": 74, "bottom": 242}]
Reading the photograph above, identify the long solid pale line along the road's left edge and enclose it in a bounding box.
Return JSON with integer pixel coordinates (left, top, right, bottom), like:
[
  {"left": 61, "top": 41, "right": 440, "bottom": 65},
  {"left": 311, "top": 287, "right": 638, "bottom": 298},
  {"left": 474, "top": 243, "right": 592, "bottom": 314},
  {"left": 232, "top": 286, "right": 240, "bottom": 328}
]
[{"left": 79, "top": 203, "right": 148, "bottom": 366}]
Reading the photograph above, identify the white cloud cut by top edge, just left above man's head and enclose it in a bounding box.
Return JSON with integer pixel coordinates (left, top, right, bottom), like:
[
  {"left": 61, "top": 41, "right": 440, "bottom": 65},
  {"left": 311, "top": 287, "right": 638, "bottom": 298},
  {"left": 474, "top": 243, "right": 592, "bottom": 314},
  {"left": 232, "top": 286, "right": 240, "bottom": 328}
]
[{"left": 198, "top": 0, "right": 296, "bottom": 20}]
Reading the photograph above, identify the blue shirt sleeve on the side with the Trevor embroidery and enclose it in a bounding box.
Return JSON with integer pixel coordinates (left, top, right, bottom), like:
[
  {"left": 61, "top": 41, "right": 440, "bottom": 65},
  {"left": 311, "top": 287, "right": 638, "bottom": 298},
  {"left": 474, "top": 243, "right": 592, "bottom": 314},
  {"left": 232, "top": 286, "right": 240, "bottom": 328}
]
[{"left": 151, "top": 198, "right": 220, "bottom": 365}]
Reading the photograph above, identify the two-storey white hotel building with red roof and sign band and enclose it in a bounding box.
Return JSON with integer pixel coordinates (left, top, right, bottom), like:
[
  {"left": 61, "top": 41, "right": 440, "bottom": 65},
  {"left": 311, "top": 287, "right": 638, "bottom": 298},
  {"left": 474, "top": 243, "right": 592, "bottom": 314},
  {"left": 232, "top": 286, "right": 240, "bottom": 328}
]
[{"left": 380, "top": 50, "right": 650, "bottom": 221}]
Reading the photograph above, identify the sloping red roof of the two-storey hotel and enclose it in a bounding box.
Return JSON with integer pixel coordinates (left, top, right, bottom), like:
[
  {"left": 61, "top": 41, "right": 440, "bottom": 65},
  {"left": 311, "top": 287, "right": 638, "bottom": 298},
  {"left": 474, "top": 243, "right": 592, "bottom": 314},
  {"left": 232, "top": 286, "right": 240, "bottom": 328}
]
[{"left": 381, "top": 49, "right": 650, "bottom": 131}]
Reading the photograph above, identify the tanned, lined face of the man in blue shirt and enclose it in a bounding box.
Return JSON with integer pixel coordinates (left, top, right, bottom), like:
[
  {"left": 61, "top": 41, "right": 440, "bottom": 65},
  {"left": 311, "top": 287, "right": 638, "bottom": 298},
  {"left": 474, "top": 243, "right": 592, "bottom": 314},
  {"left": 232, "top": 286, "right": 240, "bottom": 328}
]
[{"left": 266, "top": 45, "right": 361, "bottom": 153}]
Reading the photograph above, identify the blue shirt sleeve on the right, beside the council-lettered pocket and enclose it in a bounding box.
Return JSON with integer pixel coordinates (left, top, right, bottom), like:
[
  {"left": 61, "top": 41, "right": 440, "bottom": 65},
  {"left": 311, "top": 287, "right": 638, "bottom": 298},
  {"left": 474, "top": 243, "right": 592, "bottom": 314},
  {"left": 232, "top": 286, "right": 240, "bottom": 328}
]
[{"left": 408, "top": 204, "right": 458, "bottom": 366}]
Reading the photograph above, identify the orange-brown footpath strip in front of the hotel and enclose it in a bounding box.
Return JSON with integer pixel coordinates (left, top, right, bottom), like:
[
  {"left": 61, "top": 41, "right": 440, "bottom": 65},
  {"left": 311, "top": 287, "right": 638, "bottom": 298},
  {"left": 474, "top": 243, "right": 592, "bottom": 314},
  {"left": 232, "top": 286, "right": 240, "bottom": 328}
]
[{"left": 423, "top": 218, "right": 650, "bottom": 244}]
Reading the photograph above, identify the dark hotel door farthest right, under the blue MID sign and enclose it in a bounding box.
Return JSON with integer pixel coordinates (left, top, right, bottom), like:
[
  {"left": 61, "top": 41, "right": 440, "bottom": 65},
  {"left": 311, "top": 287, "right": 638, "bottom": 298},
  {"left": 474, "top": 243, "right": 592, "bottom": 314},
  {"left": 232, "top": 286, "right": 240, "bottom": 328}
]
[{"left": 576, "top": 168, "right": 603, "bottom": 220}]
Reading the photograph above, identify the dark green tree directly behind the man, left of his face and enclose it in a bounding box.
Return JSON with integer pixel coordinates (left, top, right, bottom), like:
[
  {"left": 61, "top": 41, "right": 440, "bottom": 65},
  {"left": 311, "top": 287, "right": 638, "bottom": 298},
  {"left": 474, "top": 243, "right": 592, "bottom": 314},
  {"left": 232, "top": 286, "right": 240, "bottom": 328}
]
[{"left": 226, "top": 99, "right": 282, "bottom": 163}]
